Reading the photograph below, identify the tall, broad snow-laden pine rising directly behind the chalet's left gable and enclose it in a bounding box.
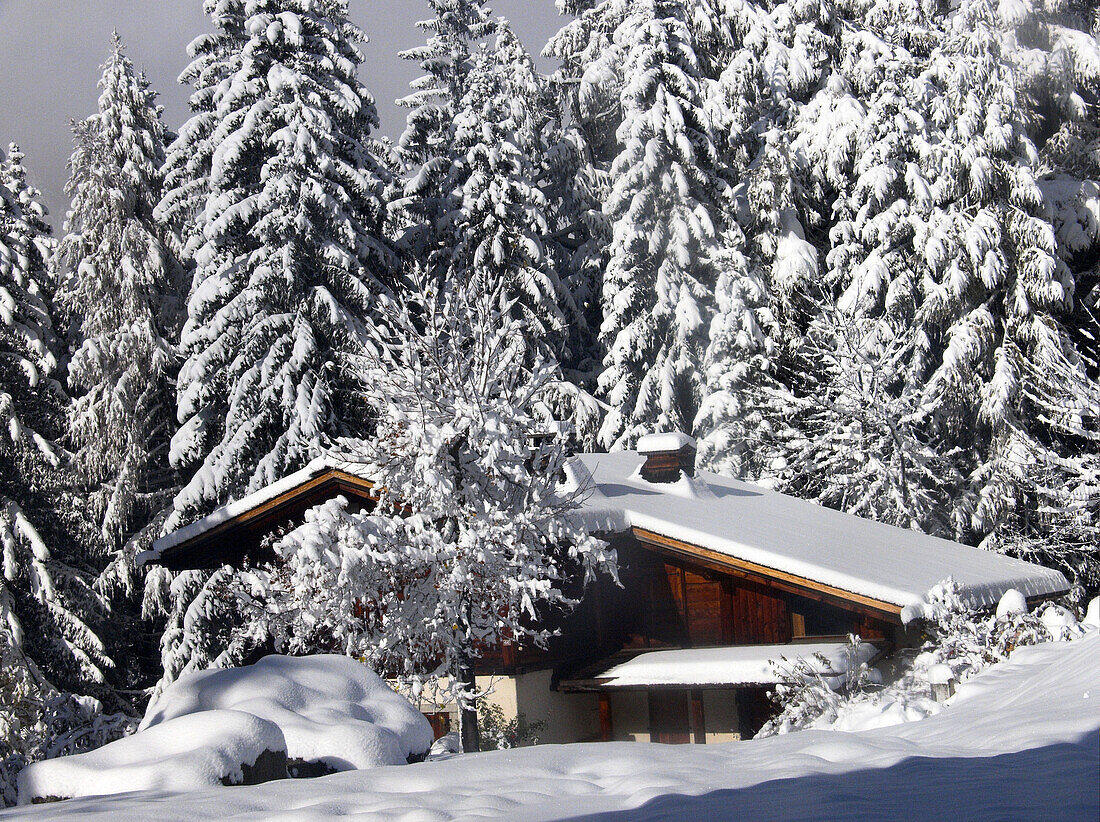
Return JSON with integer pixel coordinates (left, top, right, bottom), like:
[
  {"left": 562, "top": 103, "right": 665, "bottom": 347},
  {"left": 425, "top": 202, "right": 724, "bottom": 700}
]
[{"left": 157, "top": 0, "right": 393, "bottom": 529}]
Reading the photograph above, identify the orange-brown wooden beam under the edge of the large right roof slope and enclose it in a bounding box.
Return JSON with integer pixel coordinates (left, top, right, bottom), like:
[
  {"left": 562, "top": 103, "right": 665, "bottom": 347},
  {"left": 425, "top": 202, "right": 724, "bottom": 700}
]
[{"left": 633, "top": 528, "right": 901, "bottom": 624}]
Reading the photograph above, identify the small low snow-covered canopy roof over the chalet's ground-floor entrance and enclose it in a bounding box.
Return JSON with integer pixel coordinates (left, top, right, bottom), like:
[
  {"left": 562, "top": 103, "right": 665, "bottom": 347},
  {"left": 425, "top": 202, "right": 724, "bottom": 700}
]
[{"left": 596, "top": 643, "right": 878, "bottom": 688}]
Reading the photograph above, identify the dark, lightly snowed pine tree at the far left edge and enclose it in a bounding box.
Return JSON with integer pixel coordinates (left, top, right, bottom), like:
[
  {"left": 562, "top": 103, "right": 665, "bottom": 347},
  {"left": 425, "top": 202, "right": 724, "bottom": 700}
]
[{"left": 0, "top": 145, "right": 123, "bottom": 801}]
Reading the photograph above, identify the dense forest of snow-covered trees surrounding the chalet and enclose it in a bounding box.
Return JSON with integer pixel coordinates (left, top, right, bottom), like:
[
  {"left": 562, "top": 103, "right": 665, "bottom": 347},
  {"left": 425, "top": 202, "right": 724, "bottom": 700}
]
[{"left": 0, "top": 0, "right": 1100, "bottom": 801}]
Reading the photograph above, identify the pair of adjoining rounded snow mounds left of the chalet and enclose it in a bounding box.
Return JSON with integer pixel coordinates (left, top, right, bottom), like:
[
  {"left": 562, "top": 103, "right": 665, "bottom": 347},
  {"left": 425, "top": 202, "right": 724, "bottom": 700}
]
[{"left": 19, "top": 655, "right": 433, "bottom": 804}]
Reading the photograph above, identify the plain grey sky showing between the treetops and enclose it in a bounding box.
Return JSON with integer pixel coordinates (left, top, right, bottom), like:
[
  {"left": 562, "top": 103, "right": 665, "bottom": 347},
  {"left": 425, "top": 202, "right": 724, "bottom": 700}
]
[{"left": 0, "top": 0, "right": 562, "bottom": 229}]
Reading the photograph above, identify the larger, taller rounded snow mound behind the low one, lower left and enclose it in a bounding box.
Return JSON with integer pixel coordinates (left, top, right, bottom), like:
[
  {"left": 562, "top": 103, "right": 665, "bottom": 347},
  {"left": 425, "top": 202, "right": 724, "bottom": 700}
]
[{"left": 139, "top": 655, "right": 433, "bottom": 772}]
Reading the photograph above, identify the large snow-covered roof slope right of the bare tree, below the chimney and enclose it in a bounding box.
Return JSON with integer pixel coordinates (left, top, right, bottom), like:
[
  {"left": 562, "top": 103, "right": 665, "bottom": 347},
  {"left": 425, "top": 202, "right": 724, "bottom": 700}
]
[{"left": 569, "top": 451, "right": 1069, "bottom": 609}]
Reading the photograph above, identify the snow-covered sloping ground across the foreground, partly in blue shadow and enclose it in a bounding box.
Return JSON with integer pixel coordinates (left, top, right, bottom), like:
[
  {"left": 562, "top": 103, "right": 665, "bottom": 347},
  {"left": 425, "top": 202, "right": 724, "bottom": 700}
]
[{"left": 10, "top": 631, "right": 1100, "bottom": 822}]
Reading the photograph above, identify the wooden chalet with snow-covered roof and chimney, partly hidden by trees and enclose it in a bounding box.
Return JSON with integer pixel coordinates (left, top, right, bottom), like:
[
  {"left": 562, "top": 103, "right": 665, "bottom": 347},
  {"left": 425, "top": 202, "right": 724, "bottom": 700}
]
[{"left": 145, "top": 434, "right": 1069, "bottom": 743}]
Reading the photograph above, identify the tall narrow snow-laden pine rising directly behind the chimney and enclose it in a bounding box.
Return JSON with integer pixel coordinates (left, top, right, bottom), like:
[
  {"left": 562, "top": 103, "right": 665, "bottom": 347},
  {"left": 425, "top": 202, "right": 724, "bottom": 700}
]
[{"left": 600, "top": 0, "right": 723, "bottom": 447}]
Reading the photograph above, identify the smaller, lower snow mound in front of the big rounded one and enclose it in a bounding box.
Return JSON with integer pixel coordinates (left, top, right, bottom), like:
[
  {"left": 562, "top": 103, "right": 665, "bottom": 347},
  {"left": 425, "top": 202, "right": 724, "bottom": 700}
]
[{"left": 19, "top": 711, "right": 286, "bottom": 804}]
